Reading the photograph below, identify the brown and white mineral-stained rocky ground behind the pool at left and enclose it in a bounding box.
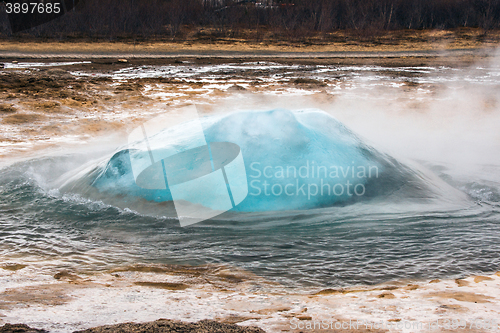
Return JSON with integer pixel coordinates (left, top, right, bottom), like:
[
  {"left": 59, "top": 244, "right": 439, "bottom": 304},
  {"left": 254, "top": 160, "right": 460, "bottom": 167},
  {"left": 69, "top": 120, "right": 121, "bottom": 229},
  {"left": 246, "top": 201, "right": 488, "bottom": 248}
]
[{"left": 0, "top": 54, "right": 490, "bottom": 161}]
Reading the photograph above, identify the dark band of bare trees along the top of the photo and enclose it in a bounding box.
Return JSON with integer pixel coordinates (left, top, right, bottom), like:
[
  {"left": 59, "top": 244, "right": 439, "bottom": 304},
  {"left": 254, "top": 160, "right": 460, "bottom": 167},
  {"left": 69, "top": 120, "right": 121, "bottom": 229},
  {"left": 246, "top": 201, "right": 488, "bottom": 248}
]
[{"left": 0, "top": 0, "right": 500, "bottom": 40}]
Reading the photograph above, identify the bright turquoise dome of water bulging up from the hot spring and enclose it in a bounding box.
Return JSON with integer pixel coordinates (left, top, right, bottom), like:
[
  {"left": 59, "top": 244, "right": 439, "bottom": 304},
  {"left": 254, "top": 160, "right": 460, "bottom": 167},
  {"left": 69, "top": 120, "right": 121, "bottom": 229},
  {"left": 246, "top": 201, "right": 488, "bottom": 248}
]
[{"left": 77, "top": 107, "right": 454, "bottom": 220}]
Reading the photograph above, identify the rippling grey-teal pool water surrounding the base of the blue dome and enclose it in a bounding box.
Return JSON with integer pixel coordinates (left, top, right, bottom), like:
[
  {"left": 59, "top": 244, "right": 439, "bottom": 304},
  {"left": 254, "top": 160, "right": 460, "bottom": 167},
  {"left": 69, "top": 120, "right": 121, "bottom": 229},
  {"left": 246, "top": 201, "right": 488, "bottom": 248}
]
[{"left": 0, "top": 124, "right": 500, "bottom": 286}]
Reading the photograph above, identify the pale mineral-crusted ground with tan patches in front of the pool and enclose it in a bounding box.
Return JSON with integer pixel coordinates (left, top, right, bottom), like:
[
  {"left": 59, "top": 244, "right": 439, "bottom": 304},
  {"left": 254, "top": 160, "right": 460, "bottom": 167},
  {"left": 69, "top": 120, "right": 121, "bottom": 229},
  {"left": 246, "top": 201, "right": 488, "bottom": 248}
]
[{"left": 0, "top": 267, "right": 500, "bottom": 332}]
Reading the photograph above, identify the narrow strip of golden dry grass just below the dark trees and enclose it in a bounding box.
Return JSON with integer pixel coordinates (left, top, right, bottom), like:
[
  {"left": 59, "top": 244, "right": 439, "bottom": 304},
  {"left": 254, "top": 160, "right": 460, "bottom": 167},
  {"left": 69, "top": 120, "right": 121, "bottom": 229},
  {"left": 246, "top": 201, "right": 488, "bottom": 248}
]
[{"left": 0, "top": 29, "right": 500, "bottom": 56}]
